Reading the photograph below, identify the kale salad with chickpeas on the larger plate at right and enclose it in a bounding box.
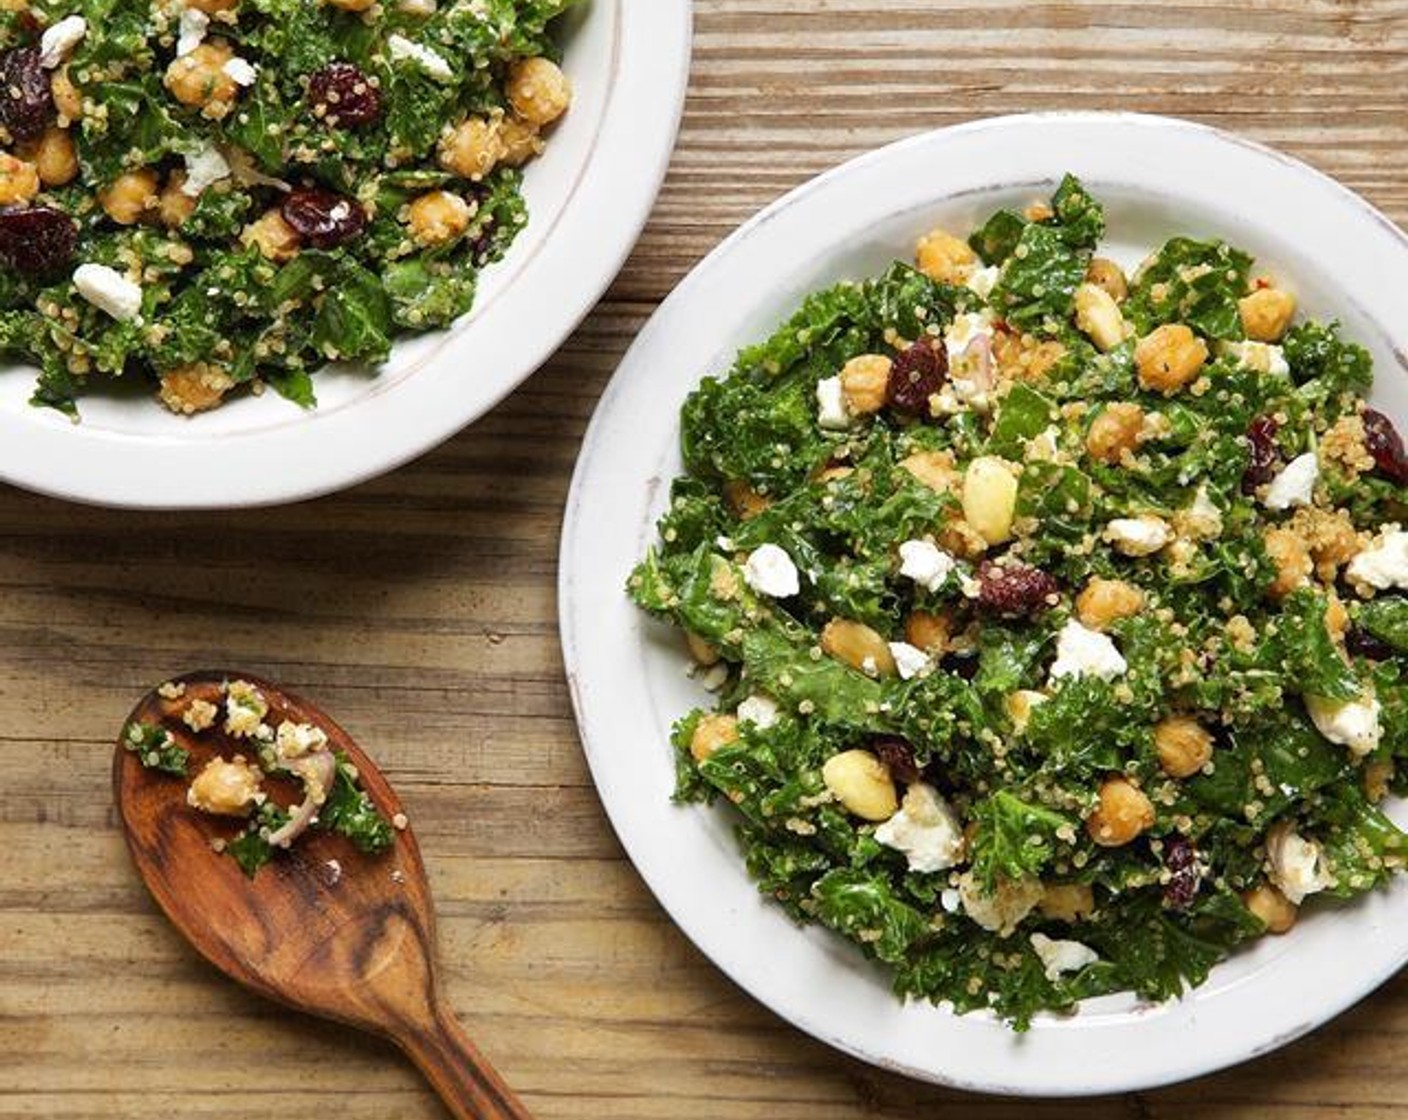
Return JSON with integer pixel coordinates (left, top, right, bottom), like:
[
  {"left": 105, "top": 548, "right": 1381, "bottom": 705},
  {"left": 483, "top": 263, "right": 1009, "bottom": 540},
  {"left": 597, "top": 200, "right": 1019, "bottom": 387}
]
[{"left": 629, "top": 176, "right": 1408, "bottom": 1028}]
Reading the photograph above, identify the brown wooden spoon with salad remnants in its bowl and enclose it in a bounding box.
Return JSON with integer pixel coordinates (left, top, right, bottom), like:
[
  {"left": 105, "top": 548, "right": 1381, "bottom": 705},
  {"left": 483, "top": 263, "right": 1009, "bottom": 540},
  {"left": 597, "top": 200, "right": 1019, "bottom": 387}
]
[{"left": 113, "top": 672, "right": 531, "bottom": 1120}]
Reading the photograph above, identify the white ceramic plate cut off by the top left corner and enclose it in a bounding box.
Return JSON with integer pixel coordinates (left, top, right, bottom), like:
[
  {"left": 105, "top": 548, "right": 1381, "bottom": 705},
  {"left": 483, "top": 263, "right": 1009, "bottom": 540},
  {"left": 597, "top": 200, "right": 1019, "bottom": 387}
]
[{"left": 0, "top": 0, "right": 691, "bottom": 509}]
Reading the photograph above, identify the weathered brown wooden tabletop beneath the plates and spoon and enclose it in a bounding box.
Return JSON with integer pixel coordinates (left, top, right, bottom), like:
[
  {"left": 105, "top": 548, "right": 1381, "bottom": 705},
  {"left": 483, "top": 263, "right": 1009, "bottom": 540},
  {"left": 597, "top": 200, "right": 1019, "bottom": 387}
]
[{"left": 8, "top": 0, "right": 1408, "bottom": 1120}]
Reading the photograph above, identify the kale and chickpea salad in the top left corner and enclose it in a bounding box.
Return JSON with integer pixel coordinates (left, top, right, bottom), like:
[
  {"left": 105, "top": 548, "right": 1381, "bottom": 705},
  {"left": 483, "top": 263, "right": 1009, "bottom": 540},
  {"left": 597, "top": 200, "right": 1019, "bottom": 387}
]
[{"left": 0, "top": 0, "right": 572, "bottom": 417}]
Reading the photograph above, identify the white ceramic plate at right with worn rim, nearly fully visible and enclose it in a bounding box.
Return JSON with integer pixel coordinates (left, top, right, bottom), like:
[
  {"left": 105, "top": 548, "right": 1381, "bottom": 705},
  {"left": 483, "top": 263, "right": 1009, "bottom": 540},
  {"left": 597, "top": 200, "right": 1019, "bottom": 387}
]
[{"left": 559, "top": 114, "right": 1408, "bottom": 1095}]
